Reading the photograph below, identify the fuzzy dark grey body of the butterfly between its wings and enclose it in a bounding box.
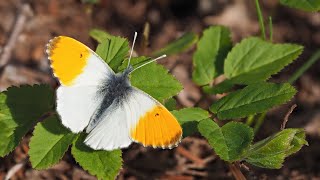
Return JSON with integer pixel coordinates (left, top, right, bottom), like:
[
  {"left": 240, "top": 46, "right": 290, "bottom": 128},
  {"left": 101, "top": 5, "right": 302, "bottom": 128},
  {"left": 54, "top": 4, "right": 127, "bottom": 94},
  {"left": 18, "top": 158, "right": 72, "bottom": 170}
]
[{"left": 87, "top": 66, "right": 132, "bottom": 132}]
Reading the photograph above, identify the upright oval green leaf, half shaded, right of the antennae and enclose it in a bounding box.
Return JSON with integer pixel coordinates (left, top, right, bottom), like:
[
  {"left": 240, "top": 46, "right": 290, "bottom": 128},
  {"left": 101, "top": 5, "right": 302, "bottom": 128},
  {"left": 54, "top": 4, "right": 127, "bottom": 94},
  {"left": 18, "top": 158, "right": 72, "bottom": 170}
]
[{"left": 192, "top": 26, "right": 232, "bottom": 85}]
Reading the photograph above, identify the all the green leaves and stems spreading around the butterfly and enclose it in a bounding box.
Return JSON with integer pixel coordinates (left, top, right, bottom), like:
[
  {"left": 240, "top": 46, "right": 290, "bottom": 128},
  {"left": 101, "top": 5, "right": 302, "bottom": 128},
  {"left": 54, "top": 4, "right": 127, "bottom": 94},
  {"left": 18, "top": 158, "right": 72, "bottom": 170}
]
[{"left": 0, "top": 1, "right": 319, "bottom": 179}]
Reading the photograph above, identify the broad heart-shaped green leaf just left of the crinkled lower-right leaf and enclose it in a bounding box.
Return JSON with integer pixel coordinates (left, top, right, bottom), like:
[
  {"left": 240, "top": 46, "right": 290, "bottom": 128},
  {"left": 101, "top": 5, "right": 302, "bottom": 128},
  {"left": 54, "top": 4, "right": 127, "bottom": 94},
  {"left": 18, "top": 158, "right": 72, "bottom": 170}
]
[{"left": 198, "top": 119, "right": 253, "bottom": 162}]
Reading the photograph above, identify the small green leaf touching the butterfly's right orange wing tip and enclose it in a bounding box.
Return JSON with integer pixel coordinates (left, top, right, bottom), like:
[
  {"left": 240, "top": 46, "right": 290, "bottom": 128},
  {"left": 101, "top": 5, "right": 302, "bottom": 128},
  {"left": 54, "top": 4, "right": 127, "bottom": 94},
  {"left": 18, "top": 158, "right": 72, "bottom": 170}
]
[{"left": 171, "top": 107, "right": 210, "bottom": 125}]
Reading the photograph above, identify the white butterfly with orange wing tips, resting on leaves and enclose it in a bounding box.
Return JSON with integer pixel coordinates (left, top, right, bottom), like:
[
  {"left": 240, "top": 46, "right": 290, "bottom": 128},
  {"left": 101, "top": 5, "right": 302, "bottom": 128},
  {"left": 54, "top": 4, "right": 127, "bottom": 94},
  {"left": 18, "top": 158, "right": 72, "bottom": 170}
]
[{"left": 46, "top": 34, "right": 182, "bottom": 150}]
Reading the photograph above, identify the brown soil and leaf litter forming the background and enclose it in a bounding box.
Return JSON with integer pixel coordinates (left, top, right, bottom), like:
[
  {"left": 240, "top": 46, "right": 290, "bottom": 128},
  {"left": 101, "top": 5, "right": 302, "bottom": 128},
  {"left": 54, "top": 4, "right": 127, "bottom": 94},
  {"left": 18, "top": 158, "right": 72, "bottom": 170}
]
[{"left": 0, "top": 0, "right": 320, "bottom": 179}]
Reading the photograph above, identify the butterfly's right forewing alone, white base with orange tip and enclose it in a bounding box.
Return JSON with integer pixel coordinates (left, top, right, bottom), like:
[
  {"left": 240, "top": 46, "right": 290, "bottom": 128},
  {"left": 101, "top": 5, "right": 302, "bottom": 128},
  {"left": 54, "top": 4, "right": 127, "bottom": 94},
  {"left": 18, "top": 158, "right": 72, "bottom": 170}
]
[{"left": 128, "top": 89, "right": 182, "bottom": 148}]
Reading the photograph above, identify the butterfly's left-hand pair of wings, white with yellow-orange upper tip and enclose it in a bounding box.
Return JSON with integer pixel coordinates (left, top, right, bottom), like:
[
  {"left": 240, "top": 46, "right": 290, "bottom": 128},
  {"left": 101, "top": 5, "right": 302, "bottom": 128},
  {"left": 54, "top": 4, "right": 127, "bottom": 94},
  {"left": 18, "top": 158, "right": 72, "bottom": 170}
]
[{"left": 46, "top": 36, "right": 114, "bottom": 133}]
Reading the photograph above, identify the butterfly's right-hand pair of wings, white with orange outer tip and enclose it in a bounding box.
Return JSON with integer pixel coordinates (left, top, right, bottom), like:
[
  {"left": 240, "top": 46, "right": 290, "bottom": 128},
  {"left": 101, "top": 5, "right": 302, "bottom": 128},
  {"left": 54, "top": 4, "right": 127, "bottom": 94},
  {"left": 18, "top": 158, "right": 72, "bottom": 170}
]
[{"left": 85, "top": 88, "right": 182, "bottom": 150}]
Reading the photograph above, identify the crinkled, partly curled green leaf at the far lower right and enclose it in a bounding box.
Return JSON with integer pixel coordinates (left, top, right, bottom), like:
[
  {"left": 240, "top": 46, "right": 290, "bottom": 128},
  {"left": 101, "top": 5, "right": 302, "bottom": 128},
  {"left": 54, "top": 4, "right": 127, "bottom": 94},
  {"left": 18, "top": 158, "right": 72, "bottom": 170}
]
[{"left": 244, "top": 129, "right": 308, "bottom": 169}]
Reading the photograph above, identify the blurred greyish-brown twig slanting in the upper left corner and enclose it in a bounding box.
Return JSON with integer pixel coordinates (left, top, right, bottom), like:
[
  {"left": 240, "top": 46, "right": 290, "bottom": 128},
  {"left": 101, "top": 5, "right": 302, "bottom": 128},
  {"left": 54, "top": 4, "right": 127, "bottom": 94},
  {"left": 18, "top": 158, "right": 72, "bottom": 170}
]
[{"left": 0, "top": 4, "right": 32, "bottom": 69}]
